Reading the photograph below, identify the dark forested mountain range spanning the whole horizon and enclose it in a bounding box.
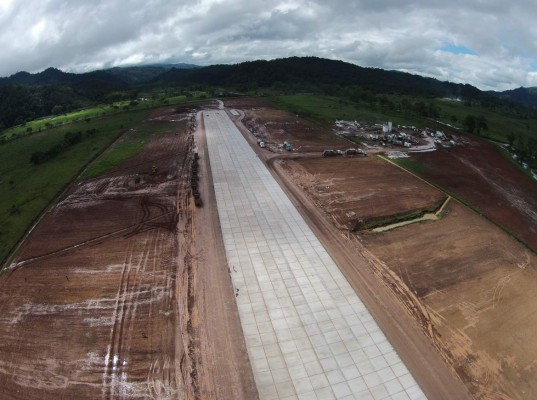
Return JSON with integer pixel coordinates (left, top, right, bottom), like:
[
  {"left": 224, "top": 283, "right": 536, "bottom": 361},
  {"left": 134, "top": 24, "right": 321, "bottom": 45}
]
[{"left": 0, "top": 57, "right": 537, "bottom": 130}]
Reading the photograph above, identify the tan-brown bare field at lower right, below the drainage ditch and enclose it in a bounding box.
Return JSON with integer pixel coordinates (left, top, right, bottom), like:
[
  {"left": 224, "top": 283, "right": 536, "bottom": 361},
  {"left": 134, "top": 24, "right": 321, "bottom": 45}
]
[{"left": 359, "top": 202, "right": 537, "bottom": 399}]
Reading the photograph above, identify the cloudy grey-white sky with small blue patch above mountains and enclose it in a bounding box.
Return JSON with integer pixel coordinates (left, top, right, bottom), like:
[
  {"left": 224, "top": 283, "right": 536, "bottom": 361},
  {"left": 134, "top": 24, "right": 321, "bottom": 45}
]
[{"left": 0, "top": 0, "right": 537, "bottom": 90}]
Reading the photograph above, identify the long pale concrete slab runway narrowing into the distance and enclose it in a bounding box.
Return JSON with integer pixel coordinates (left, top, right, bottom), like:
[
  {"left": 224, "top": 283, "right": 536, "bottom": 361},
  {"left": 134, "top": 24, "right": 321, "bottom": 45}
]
[{"left": 203, "top": 110, "right": 425, "bottom": 400}]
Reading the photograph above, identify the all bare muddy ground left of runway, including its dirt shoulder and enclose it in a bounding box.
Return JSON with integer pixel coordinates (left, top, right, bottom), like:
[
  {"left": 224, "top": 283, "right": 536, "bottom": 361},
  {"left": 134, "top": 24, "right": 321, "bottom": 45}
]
[{"left": 0, "top": 109, "right": 257, "bottom": 399}]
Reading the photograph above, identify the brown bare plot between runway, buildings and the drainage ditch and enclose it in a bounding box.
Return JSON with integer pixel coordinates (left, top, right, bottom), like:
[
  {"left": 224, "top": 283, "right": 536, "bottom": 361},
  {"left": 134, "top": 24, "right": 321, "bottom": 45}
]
[{"left": 276, "top": 156, "right": 445, "bottom": 230}]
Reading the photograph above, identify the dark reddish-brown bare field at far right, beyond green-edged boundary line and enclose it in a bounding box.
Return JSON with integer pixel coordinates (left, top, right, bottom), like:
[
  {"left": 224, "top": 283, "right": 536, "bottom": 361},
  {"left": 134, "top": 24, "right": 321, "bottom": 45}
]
[{"left": 410, "top": 138, "right": 537, "bottom": 251}]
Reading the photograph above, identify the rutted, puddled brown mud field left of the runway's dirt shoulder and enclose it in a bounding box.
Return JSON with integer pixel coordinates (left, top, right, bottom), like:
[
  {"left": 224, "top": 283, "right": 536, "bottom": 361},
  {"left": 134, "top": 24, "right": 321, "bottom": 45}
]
[{"left": 0, "top": 114, "right": 199, "bottom": 400}]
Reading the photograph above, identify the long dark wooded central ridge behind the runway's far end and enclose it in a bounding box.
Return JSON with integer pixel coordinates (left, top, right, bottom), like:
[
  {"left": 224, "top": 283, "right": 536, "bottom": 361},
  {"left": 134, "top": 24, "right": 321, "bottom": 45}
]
[{"left": 155, "top": 57, "right": 483, "bottom": 98}]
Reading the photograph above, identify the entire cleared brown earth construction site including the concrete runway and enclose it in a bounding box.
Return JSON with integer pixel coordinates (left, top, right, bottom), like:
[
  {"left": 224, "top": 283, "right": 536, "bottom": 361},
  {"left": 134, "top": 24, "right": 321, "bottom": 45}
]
[{"left": 0, "top": 98, "right": 537, "bottom": 400}]
